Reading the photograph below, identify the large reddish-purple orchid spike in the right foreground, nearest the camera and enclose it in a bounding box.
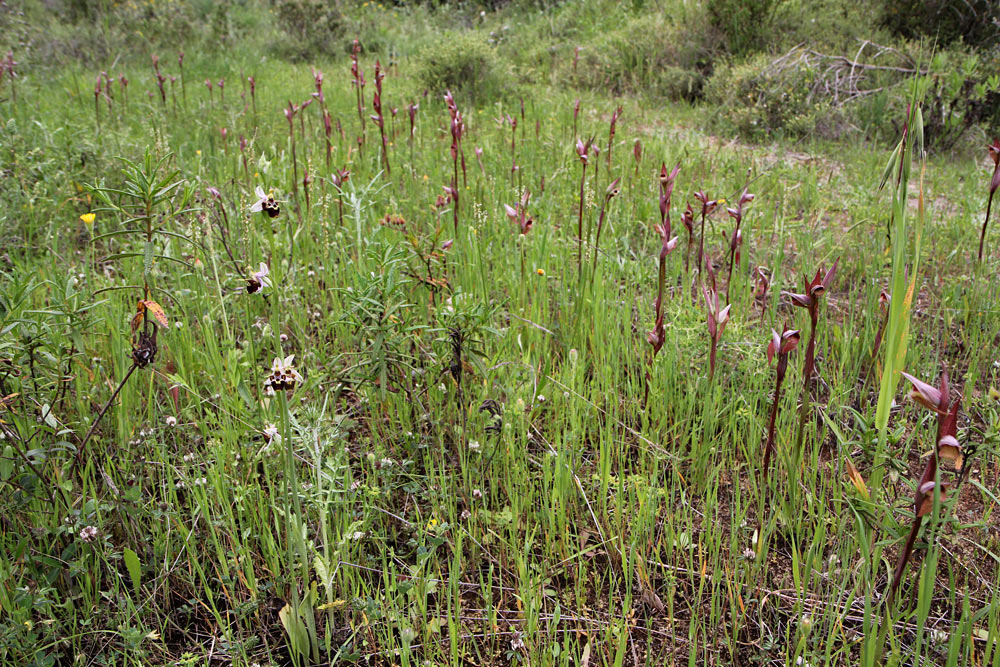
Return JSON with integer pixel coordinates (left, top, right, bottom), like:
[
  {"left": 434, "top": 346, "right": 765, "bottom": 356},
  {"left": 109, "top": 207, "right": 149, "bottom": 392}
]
[{"left": 886, "top": 369, "right": 963, "bottom": 607}]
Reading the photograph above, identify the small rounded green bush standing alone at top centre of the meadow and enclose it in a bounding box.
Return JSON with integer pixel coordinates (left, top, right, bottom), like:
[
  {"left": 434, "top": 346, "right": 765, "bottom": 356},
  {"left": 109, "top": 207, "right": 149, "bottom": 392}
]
[{"left": 416, "top": 31, "right": 512, "bottom": 99}]
